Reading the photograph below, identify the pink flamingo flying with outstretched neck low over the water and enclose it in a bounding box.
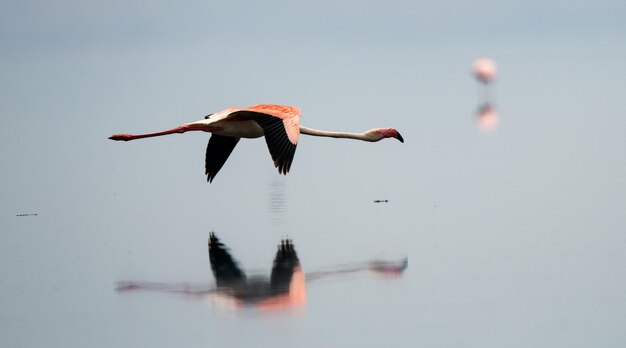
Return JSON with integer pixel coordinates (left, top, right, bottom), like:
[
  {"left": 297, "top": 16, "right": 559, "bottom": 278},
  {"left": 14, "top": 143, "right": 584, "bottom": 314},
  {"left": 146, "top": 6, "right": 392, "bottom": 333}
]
[{"left": 109, "top": 104, "right": 404, "bottom": 183}]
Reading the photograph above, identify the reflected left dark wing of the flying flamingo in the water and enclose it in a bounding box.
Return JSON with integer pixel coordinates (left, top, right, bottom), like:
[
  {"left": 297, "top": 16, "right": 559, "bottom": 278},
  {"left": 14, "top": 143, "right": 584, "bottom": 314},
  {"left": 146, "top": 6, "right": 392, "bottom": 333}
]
[{"left": 209, "top": 233, "right": 246, "bottom": 287}]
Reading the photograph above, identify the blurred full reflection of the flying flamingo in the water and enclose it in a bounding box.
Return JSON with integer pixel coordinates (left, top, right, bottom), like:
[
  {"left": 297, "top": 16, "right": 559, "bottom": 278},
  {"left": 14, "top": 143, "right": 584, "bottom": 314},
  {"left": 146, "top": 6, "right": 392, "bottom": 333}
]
[{"left": 116, "top": 233, "right": 408, "bottom": 309}]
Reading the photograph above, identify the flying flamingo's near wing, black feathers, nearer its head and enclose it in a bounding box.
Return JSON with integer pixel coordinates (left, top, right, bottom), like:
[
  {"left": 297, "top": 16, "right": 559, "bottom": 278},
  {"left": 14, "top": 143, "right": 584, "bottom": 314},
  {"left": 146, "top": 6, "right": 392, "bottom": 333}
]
[{"left": 231, "top": 110, "right": 298, "bottom": 174}]
